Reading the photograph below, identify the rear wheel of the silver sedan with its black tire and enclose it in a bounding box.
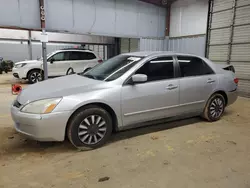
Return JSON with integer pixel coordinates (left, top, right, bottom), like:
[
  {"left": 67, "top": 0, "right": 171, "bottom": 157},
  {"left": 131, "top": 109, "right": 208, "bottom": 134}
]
[{"left": 202, "top": 93, "right": 226, "bottom": 122}]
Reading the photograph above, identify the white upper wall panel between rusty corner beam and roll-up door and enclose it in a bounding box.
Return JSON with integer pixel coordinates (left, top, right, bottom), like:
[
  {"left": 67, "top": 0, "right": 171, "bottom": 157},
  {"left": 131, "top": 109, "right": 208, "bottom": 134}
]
[{"left": 170, "top": 0, "right": 208, "bottom": 37}]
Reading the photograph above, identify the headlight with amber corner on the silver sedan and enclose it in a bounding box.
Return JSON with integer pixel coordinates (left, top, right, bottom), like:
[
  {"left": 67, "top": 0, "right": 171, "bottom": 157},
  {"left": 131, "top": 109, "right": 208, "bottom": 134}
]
[{"left": 21, "top": 98, "right": 62, "bottom": 114}]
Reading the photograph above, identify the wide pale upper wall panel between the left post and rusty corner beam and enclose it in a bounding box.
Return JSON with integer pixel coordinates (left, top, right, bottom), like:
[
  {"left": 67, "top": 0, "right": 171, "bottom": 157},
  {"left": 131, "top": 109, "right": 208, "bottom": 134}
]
[{"left": 45, "top": 0, "right": 166, "bottom": 38}]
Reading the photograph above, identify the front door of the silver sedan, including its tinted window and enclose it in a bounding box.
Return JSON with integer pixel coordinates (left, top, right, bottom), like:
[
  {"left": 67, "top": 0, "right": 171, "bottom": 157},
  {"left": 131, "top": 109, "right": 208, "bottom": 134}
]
[{"left": 121, "top": 57, "right": 179, "bottom": 126}]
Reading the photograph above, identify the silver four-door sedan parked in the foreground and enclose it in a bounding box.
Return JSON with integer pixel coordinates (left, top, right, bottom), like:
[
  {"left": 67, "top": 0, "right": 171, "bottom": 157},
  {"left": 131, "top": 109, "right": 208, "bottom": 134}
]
[{"left": 11, "top": 52, "right": 238, "bottom": 148}]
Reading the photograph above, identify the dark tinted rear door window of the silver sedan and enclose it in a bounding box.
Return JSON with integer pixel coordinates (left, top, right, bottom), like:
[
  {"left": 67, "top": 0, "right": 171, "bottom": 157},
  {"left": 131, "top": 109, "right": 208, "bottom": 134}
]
[{"left": 177, "top": 56, "right": 214, "bottom": 77}]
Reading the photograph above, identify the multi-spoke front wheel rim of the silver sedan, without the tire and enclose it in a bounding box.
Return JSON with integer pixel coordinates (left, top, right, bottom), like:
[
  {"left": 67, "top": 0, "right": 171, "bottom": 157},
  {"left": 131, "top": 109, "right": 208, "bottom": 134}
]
[{"left": 78, "top": 115, "right": 107, "bottom": 145}]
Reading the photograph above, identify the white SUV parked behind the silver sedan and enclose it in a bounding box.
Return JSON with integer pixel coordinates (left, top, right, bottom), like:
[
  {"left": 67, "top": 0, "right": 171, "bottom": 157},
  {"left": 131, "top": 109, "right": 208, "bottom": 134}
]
[{"left": 13, "top": 49, "right": 102, "bottom": 84}]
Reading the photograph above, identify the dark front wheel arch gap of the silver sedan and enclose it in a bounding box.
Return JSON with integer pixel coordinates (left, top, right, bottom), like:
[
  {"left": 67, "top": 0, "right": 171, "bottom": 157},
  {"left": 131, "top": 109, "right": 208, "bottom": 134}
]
[{"left": 65, "top": 102, "right": 118, "bottom": 138}]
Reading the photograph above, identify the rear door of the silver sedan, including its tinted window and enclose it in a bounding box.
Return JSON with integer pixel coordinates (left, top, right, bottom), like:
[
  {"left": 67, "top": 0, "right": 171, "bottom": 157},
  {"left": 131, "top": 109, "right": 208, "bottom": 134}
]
[{"left": 177, "top": 56, "right": 218, "bottom": 112}]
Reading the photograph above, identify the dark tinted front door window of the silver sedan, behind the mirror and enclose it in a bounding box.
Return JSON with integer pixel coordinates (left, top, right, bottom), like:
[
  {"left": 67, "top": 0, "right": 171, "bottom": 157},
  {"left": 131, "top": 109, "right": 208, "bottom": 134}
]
[{"left": 136, "top": 57, "right": 174, "bottom": 81}]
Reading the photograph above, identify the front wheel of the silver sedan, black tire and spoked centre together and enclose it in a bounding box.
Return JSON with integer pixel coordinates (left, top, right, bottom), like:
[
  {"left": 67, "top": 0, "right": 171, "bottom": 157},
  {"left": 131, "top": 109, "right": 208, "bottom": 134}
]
[{"left": 67, "top": 105, "right": 113, "bottom": 149}]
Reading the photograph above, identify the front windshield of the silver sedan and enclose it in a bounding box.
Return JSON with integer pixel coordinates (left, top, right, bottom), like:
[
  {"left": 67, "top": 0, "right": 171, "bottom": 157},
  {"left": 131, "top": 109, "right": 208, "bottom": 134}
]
[{"left": 81, "top": 55, "right": 142, "bottom": 81}]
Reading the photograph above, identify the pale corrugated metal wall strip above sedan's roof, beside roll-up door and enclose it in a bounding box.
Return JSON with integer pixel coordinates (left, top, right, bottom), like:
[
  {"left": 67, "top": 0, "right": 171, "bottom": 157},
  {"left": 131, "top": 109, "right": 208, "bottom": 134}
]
[{"left": 168, "top": 35, "right": 206, "bottom": 57}]
